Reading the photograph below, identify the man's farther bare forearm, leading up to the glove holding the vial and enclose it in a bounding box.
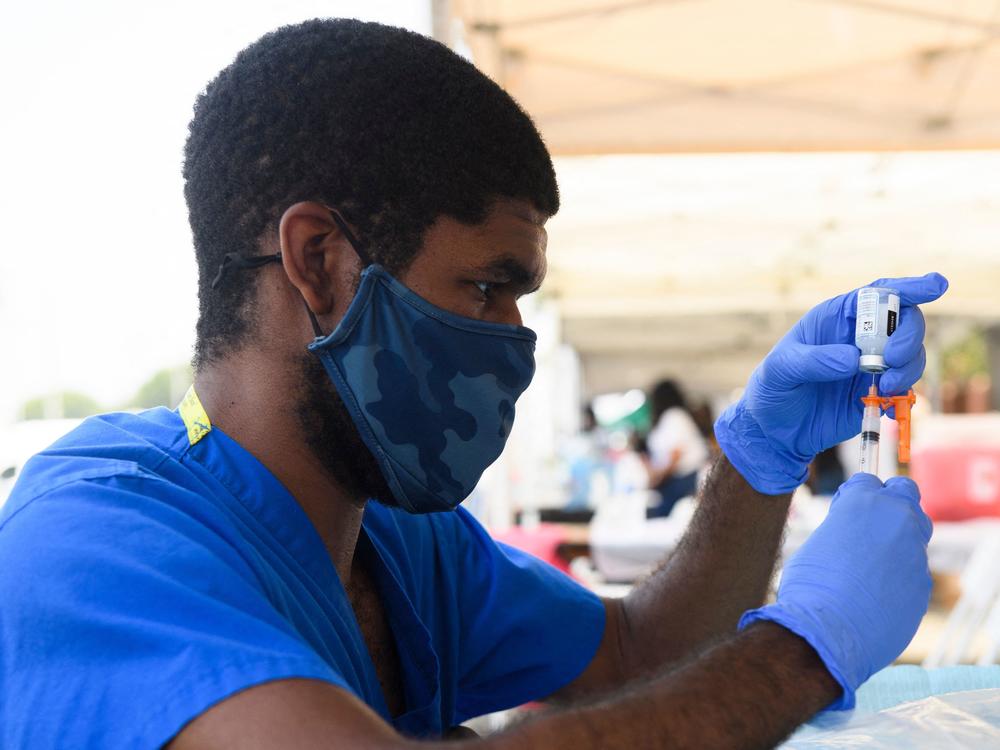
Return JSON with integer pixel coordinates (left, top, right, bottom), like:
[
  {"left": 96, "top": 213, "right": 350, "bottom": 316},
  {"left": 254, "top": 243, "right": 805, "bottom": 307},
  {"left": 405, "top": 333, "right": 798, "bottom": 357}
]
[{"left": 620, "top": 456, "right": 791, "bottom": 676}]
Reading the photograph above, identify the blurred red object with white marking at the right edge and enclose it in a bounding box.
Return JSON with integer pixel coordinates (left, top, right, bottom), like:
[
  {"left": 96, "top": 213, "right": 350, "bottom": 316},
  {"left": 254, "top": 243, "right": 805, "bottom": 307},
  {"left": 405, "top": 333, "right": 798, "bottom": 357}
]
[{"left": 910, "top": 447, "right": 1000, "bottom": 521}]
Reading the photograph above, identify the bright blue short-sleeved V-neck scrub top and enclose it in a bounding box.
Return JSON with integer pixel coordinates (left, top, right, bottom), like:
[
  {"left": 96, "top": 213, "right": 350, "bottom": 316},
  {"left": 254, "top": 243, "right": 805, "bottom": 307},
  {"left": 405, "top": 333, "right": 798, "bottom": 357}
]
[{"left": 0, "top": 400, "right": 604, "bottom": 748}]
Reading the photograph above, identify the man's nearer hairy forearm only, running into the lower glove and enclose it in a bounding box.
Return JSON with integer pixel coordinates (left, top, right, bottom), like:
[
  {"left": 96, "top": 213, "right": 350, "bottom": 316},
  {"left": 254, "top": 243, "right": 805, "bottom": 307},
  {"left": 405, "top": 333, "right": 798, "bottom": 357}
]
[{"left": 477, "top": 623, "right": 840, "bottom": 750}]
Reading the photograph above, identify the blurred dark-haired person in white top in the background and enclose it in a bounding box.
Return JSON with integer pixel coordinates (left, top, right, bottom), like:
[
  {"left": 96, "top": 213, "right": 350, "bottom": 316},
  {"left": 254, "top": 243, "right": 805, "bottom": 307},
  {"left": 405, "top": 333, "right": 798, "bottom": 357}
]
[{"left": 645, "top": 380, "right": 708, "bottom": 518}]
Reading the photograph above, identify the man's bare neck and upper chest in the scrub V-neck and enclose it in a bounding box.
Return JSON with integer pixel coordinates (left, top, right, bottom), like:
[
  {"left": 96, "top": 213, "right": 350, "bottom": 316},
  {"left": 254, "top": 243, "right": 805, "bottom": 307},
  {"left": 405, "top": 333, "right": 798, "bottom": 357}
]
[{"left": 194, "top": 352, "right": 364, "bottom": 587}]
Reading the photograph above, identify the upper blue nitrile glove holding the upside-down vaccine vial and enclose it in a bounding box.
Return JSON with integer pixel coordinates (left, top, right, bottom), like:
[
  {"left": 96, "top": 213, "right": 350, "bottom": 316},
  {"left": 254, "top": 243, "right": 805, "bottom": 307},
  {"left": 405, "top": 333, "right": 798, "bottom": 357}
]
[{"left": 715, "top": 273, "right": 948, "bottom": 495}]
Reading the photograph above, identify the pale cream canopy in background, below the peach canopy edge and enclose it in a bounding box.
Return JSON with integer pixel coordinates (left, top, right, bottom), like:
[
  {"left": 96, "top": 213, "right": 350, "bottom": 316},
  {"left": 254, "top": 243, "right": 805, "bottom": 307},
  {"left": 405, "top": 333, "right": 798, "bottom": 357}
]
[{"left": 542, "top": 152, "right": 1000, "bottom": 394}]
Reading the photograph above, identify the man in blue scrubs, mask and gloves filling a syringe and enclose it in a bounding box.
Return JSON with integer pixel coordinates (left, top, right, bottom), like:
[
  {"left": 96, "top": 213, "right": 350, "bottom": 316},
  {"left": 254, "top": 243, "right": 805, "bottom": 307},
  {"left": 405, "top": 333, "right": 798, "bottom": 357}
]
[{"left": 0, "top": 20, "right": 946, "bottom": 750}]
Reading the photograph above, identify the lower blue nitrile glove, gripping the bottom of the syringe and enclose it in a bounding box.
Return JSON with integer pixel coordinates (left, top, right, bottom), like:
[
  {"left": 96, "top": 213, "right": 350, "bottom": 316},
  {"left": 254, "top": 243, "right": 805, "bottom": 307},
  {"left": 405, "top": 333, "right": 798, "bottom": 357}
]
[{"left": 739, "top": 474, "right": 931, "bottom": 709}]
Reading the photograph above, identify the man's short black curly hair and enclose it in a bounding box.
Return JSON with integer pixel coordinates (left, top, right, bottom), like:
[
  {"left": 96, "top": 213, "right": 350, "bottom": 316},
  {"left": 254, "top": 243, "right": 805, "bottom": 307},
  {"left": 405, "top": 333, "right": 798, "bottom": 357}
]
[{"left": 184, "top": 19, "right": 559, "bottom": 365}]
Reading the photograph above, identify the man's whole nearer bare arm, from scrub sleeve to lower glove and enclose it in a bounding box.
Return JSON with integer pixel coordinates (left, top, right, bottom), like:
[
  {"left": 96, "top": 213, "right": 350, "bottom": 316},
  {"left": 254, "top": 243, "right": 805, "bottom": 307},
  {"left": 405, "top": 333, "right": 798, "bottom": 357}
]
[{"left": 170, "top": 622, "right": 841, "bottom": 750}]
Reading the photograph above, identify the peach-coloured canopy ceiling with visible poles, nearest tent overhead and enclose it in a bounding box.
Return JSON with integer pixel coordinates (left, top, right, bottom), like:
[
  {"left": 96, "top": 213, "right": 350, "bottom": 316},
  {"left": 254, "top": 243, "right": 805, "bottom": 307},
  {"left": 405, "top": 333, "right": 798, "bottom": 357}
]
[{"left": 451, "top": 0, "right": 1000, "bottom": 154}]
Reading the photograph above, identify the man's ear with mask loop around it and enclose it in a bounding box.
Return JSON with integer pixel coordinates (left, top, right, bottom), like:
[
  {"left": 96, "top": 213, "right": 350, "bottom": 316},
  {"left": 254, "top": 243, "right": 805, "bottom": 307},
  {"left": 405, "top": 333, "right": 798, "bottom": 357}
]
[{"left": 278, "top": 201, "right": 358, "bottom": 316}]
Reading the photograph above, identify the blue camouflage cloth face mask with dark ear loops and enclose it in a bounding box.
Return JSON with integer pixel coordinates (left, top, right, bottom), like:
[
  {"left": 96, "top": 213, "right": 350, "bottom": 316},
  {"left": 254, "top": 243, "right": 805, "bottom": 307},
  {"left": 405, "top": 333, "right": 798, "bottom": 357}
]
[{"left": 213, "top": 212, "right": 536, "bottom": 513}]
